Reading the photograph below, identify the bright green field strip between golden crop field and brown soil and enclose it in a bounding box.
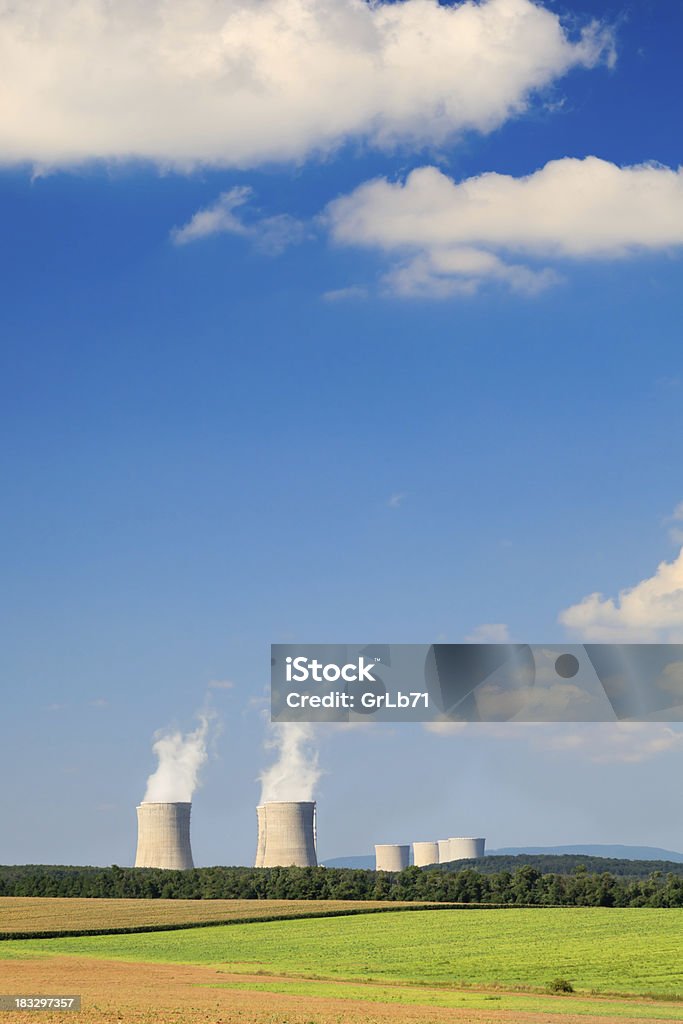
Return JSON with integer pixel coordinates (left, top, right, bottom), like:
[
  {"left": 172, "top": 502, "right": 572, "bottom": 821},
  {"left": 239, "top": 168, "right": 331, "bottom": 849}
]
[{"left": 0, "top": 907, "right": 683, "bottom": 995}]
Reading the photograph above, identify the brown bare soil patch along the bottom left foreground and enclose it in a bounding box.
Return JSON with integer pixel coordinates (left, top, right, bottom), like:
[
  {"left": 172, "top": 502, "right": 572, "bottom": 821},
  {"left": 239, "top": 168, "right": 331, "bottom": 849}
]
[{"left": 2, "top": 956, "right": 670, "bottom": 1024}]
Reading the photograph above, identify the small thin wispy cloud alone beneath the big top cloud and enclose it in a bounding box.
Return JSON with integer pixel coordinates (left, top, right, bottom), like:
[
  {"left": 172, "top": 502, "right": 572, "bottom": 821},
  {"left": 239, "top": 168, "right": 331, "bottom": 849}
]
[{"left": 171, "top": 185, "right": 306, "bottom": 256}]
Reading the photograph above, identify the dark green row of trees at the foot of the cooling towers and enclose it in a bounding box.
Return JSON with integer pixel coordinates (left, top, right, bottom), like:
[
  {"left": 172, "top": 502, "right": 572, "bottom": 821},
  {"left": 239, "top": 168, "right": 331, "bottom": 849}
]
[{"left": 0, "top": 864, "right": 683, "bottom": 907}]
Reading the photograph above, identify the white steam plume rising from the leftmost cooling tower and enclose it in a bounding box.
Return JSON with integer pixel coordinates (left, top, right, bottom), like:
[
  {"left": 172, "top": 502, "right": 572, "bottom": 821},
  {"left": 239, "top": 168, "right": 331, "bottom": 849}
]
[{"left": 143, "top": 712, "right": 212, "bottom": 804}]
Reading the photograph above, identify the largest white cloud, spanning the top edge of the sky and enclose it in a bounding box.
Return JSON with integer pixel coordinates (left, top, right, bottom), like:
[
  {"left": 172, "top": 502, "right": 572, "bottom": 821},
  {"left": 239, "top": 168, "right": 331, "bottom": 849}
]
[{"left": 0, "top": 0, "right": 613, "bottom": 168}]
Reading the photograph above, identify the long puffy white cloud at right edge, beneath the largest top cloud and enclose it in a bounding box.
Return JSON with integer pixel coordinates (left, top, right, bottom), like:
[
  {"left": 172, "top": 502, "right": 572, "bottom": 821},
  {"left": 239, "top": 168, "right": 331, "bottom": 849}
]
[{"left": 326, "top": 157, "right": 683, "bottom": 298}]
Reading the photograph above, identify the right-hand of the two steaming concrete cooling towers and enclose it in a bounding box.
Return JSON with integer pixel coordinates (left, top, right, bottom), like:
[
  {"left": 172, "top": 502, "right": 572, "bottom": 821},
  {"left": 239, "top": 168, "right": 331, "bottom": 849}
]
[{"left": 255, "top": 801, "right": 317, "bottom": 867}]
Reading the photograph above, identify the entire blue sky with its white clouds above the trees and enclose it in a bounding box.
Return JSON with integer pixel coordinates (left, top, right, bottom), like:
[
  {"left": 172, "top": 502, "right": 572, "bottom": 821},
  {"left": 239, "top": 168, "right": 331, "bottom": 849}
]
[{"left": 0, "top": 0, "right": 683, "bottom": 863}]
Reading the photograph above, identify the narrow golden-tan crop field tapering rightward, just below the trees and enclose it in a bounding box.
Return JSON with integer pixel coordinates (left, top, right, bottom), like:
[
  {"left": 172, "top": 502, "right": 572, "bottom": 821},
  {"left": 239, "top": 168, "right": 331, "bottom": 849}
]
[{"left": 0, "top": 896, "right": 432, "bottom": 935}]
